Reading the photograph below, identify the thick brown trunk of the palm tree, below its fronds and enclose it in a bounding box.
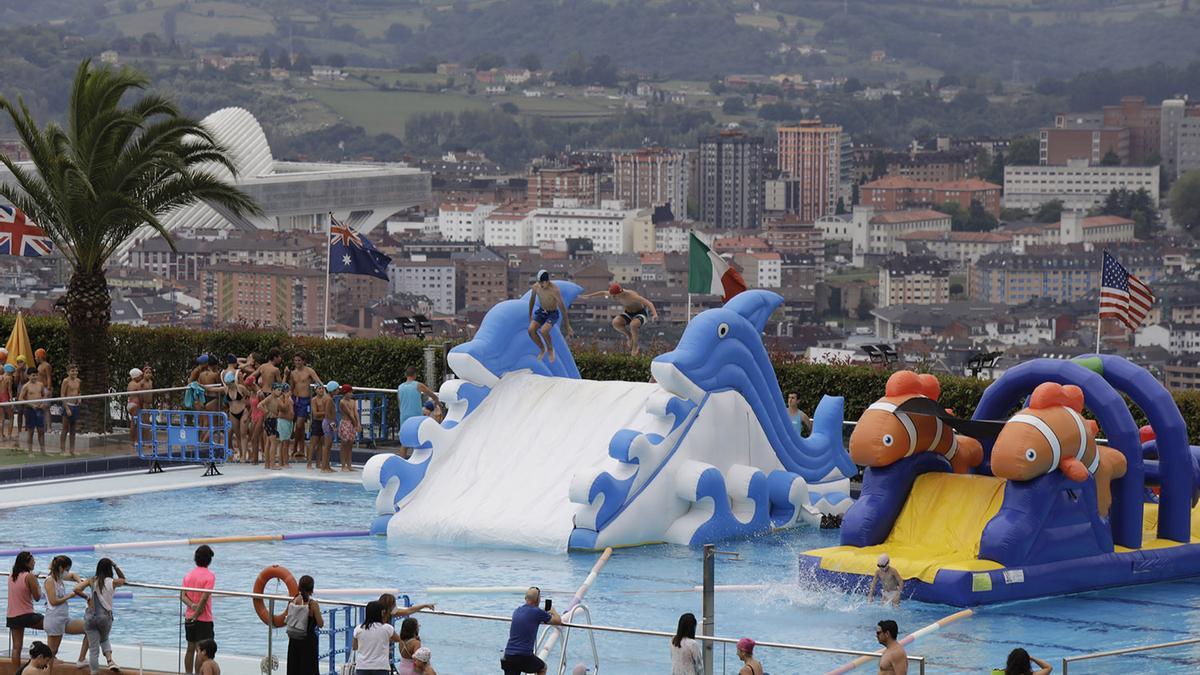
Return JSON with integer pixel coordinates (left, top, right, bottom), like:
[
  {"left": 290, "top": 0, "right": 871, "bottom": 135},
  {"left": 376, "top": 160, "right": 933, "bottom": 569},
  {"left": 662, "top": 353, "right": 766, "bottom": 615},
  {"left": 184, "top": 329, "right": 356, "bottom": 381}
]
[{"left": 62, "top": 271, "right": 112, "bottom": 432}]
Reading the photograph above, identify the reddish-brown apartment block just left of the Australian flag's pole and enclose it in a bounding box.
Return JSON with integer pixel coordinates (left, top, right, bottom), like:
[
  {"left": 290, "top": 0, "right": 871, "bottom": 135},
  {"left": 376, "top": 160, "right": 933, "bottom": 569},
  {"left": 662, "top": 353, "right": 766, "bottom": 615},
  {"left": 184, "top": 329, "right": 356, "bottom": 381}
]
[{"left": 200, "top": 264, "right": 325, "bottom": 335}]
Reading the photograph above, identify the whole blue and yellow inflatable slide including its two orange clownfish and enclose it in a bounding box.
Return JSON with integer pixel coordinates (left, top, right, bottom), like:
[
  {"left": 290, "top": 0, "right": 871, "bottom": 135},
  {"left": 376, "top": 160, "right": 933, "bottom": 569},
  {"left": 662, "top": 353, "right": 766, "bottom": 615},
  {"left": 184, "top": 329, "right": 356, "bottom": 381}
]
[{"left": 800, "top": 356, "right": 1200, "bottom": 607}]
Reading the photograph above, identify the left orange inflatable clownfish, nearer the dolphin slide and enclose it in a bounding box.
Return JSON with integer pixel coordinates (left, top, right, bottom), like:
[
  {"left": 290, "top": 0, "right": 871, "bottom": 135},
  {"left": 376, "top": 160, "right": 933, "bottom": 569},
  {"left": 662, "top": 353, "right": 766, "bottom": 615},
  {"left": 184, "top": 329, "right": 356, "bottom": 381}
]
[{"left": 850, "top": 370, "right": 983, "bottom": 473}]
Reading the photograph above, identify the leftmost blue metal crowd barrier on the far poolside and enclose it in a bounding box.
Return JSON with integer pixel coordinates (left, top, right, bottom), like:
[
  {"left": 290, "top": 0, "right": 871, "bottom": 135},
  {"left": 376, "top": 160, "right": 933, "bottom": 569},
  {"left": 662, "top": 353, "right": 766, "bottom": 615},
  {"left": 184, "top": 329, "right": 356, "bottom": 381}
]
[{"left": 137, "top": 410, "right": 230, "bottom": 476}]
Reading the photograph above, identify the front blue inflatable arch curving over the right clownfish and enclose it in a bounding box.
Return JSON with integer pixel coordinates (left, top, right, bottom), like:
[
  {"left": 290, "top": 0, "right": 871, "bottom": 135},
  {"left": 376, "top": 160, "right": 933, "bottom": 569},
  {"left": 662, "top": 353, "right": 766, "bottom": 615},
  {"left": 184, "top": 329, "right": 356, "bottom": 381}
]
[{"left": 973, "top": 359, "right": 1142, "bottom": 549}]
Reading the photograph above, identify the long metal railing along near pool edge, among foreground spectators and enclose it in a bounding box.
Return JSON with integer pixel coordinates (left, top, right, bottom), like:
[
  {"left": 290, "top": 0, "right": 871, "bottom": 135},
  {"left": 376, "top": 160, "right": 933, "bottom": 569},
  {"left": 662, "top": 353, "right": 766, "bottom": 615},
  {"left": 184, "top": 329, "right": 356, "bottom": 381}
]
[{"left": 105, "top": 581, "right": 926, "bottom": 675}]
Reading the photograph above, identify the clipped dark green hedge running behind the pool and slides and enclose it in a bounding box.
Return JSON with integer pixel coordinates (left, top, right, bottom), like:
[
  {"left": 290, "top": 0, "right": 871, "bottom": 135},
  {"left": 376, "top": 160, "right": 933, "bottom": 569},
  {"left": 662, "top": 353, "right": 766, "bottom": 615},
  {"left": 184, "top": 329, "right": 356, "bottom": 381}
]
[{"left": 7, "top": 315, "right": 1200, "bottom": 444}]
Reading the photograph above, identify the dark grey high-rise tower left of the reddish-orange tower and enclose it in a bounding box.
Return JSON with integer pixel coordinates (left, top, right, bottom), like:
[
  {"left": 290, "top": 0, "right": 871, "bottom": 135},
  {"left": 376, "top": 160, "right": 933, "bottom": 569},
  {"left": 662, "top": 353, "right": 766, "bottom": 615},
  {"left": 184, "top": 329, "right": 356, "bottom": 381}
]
[{"left": 696, "top": 131, "right": 764, "bottom": 229}]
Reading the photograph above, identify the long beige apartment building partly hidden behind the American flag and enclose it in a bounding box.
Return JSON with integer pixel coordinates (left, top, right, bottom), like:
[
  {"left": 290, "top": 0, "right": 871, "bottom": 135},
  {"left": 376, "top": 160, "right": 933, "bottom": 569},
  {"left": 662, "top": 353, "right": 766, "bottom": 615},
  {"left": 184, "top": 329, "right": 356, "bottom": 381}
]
[{"left": 967, "top": 249, "right": 1166, "bottom": 305}]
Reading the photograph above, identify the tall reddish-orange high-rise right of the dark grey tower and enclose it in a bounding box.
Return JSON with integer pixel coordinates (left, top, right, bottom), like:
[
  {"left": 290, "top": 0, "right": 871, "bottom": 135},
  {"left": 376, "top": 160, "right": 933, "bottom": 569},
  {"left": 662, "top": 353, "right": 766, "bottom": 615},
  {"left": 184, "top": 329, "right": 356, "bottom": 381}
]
[{"left": 776, "top": 119, "right": 841, "bottom": 222}]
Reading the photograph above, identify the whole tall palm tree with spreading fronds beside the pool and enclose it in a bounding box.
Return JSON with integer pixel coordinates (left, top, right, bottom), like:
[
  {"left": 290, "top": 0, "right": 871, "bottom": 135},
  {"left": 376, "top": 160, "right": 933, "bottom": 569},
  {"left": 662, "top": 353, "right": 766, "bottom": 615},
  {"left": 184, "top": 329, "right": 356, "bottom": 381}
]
[{"left": 0, "top": 60, "right": 260, "bottom": 429}]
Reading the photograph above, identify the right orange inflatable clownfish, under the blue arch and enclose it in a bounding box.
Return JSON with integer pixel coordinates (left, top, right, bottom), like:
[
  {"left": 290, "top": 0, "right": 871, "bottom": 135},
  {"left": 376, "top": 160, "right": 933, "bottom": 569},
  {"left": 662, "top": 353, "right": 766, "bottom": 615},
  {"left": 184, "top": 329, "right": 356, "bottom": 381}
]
[{"left": 991, "top": 382, "right": 1126, "bottom": 516}]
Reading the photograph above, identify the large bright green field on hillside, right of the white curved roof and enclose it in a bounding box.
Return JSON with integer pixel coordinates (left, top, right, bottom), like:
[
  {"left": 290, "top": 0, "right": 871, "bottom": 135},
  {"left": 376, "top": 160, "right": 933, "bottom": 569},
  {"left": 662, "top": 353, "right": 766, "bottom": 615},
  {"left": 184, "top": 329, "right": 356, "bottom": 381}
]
[{"left": 312, "top": 88, "right": 488, "bottom": 138}]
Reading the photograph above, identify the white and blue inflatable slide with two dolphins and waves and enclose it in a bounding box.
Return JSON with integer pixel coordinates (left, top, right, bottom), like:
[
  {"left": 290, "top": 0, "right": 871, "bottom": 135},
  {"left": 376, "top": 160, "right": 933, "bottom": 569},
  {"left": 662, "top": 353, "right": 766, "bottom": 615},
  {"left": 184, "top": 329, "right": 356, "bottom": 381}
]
[{"left": 362, "top": 281, "right": 857, "bottom": 551}]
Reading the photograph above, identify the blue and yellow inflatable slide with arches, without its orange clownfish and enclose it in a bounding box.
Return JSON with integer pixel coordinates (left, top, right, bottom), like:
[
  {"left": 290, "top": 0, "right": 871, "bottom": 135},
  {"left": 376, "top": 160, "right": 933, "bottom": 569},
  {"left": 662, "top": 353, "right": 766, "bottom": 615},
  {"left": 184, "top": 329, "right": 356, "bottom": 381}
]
[{"left": 800, "top": 356, "right": 1200, "bottom": 607}]
